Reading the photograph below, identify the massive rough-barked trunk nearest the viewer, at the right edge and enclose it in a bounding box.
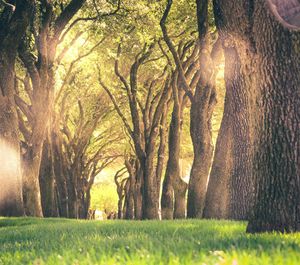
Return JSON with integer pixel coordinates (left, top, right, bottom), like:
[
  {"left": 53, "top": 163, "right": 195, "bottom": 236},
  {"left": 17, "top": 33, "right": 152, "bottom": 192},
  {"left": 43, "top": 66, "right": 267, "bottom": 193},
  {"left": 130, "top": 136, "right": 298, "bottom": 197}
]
[{"left": 247, "top": 1, "right": 300, "bottom": 232}]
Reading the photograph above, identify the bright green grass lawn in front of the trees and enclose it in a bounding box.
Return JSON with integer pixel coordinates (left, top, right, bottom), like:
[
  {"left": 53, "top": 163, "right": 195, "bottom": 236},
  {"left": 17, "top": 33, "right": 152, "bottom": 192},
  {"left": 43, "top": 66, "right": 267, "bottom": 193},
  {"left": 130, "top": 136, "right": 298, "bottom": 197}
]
[{"left": 0, "top": 218, "right": 300, "bottom": 265}]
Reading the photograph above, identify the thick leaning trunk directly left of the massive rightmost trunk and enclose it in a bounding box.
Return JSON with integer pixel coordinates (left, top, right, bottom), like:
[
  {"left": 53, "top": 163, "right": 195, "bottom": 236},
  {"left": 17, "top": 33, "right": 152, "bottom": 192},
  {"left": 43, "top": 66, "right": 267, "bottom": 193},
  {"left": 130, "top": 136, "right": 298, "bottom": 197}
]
[{"left": 204, "top": 1, "right": 254, "bottom": 220}]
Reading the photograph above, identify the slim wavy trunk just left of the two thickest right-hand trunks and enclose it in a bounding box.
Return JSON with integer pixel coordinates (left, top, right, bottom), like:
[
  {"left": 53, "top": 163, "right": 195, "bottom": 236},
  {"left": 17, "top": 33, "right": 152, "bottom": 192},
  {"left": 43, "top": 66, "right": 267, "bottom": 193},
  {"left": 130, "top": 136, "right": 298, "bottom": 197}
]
[{"left": 187, "top": 0, "right": 216, "bottom": 218}]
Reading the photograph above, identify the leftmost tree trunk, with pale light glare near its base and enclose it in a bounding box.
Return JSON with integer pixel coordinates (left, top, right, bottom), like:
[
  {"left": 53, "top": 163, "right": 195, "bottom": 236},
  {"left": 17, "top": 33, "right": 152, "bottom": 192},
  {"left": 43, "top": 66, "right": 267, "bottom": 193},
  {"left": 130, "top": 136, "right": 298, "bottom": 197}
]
[{"left": 0, "top": 1, "right": 34, "bottom": 216}]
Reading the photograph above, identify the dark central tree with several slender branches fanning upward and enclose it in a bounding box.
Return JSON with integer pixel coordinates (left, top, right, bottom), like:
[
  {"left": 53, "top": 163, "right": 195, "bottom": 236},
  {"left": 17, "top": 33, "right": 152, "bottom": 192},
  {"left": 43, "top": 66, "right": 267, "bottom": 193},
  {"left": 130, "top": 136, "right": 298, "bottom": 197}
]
[{"left": 99, "top": 38, "right": 171, "bottom": 219}]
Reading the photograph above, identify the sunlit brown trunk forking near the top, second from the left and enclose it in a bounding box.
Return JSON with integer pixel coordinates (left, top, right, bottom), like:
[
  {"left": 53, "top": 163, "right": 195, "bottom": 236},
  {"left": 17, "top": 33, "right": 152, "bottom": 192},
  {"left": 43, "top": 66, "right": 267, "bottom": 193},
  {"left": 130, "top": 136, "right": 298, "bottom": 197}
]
[{"left": 19, "top": 0, "right": 85, "bottom": 216}]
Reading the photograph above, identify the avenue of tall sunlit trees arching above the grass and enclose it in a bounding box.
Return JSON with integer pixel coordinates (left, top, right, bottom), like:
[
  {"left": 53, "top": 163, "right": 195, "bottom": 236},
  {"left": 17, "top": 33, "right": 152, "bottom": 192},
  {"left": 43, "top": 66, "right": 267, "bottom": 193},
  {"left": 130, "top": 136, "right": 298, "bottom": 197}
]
[{"left": 0, "top": 0, "right": 300, "bottom": 233}]
